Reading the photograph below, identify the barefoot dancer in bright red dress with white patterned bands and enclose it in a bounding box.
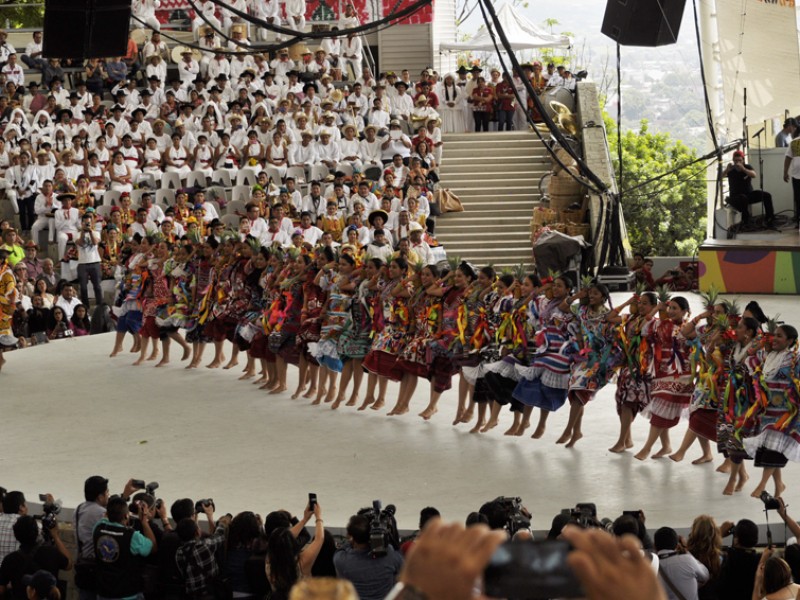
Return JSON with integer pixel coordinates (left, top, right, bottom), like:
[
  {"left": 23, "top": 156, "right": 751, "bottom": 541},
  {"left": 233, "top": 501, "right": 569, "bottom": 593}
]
[{"left": 635, "top": 296, "right": 694, "bottom": 460}]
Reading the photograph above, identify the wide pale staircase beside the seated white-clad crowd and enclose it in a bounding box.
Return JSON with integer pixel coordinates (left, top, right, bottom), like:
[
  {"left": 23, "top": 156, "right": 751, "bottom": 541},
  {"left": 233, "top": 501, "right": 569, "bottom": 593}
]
[{"left": 436, "top": 131, "right": 550, "bottom": 268}]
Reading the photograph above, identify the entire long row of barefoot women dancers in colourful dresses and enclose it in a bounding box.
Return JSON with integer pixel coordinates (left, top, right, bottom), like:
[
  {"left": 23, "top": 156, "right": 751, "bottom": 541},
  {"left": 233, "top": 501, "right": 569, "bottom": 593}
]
[{"left": 106, "top": 236, "right": 800, "bottom": 502}]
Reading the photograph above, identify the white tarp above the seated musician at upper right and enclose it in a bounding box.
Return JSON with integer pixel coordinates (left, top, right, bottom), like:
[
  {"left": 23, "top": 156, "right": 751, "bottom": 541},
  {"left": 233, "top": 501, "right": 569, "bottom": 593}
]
[{"left": 716, "top": 0, "right": 800, "bottom": 132}]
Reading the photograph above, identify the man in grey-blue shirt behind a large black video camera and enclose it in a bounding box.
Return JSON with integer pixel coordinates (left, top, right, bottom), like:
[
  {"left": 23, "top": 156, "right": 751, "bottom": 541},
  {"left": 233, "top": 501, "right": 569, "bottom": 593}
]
[{"left": 333, "top": 515, "right": 403, "bottom": 600}]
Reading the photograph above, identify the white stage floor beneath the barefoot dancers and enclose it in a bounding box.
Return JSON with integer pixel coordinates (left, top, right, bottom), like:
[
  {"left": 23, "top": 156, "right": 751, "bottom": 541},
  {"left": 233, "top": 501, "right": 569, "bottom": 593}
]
[{"left": 0, "top": 294, "right": 800, "bottom": 530}]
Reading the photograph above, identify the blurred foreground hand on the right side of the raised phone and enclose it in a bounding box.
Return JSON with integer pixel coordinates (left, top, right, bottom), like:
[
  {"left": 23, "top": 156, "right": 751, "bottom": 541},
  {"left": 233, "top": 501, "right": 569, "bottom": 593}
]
[{"left": 562, "top": 525, "right": 667, "bottom": 600}]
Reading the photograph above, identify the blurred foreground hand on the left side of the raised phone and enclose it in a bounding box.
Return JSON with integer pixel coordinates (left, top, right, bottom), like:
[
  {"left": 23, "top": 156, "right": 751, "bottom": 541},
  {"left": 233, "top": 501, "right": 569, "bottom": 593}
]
[{"left": 400, "top": 519, "right": 507, "bottom": 600}]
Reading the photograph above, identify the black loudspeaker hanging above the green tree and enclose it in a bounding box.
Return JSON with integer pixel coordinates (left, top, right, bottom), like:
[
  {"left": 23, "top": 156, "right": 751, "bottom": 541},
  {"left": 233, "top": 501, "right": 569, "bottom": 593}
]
[{"left": 601, "top": 0, "right": 686, "bottom": 46}]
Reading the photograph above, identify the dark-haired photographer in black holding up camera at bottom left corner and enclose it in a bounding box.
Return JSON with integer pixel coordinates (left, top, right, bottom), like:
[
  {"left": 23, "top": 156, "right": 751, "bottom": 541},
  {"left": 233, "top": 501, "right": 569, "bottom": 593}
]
[{"left": 0, "top": 510, "right": 72, "bottom": 600}]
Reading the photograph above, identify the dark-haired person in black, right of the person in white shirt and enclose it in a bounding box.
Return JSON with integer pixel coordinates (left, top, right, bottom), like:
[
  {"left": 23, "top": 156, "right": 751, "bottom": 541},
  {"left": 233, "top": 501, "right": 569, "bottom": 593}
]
[{"left": 718, "top": 519, "right": 760, "bottom": 600}]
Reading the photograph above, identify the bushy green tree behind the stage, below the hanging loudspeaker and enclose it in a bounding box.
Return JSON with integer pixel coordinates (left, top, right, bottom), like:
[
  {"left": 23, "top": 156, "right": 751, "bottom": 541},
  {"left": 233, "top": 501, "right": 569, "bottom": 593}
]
[{"left": 605, "top": 115, "right": 706, "bottom": 256}]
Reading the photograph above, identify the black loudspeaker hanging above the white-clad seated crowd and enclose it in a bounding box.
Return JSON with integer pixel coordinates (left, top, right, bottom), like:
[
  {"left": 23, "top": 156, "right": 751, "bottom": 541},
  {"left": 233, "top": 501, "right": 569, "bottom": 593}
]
[{"left": 42, "top": 0, "right": 131, "bottom": 59}]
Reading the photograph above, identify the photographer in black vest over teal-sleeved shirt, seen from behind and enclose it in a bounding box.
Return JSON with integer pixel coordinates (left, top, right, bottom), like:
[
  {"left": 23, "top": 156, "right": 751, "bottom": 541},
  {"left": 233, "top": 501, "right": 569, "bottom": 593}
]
[{"left": 93, "top": 496, "right": 157, "bottom": 599}]
